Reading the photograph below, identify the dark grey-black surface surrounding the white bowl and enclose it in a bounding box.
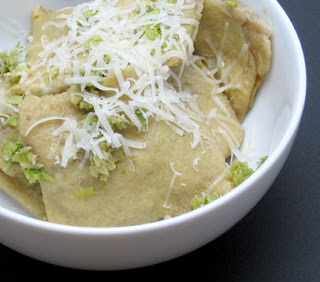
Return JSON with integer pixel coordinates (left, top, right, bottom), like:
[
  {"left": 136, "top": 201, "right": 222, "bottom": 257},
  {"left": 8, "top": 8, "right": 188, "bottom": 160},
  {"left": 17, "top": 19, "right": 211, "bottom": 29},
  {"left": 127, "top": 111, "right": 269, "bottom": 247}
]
[{"left": 0, "top": 0, "right": 320, "bottom": 282}]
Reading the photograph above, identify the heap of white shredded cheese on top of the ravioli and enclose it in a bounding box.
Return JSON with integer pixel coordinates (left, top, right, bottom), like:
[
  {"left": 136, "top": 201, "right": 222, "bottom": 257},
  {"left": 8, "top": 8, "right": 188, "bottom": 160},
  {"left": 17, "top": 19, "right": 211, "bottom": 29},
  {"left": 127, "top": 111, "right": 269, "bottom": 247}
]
[{"left": 23, "top": 0, "right": 210, "bottom": 166}]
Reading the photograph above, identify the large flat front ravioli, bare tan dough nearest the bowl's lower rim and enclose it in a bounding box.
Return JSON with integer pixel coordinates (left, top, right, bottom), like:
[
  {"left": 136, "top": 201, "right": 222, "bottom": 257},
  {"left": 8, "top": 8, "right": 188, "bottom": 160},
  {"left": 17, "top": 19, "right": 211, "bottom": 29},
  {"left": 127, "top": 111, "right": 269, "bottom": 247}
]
[{"left": 19, "top": 91, "right": 232, "bottom": 226}]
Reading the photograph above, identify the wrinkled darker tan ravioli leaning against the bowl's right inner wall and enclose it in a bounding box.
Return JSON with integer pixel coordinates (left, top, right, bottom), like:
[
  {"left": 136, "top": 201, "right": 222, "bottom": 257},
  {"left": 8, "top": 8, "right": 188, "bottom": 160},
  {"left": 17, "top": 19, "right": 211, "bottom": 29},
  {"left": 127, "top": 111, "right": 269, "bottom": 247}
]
[{"left": 195, "top": 0, "right": 272, "bottom": 121}]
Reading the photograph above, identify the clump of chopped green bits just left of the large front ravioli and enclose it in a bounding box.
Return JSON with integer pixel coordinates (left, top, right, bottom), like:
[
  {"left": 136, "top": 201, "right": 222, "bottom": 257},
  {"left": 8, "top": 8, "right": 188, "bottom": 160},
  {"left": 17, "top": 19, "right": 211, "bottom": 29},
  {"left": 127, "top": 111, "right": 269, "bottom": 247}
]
[{"left": 1, "top": 141, "right": 53, "bottom": 184}]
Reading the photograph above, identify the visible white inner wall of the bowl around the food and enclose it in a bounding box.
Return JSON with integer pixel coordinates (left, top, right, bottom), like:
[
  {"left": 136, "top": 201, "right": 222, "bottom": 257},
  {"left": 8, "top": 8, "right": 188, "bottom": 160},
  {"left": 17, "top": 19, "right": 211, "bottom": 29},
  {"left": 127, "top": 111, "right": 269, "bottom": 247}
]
[{"left": 0, "top": 0, "right": 306, "bottom": 229}]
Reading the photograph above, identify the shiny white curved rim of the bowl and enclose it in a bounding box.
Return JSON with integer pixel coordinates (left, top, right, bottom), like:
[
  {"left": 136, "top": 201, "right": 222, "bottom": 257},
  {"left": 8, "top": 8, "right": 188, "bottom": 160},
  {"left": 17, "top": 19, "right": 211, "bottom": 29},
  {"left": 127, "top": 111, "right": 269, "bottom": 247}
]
[{"left": 0, "top": 0, "right": 307, "bottom": 236}]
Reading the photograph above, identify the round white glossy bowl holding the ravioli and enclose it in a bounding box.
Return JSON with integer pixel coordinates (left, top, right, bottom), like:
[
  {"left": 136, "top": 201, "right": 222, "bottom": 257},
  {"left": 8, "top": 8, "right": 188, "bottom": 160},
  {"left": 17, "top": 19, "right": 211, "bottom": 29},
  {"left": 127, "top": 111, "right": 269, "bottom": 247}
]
[{"left": 0, "top": 0, "right": 306, "bottom": 270}]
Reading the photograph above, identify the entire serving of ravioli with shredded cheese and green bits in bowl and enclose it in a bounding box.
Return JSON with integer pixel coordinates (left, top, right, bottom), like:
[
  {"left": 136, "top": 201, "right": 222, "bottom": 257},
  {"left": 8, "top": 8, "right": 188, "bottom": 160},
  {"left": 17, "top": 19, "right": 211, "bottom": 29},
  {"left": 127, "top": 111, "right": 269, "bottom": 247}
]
[{"left": 0, "top": 0, "right": 272, "bottom": 226}]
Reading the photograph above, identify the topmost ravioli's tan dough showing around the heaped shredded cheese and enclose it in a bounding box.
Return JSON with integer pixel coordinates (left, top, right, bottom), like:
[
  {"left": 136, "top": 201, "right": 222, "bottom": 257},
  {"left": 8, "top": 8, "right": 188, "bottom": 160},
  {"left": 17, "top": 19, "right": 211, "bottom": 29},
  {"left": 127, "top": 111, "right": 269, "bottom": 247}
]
[{"left": 13, "top": 0, "right": 203, "bottom": 96}]
